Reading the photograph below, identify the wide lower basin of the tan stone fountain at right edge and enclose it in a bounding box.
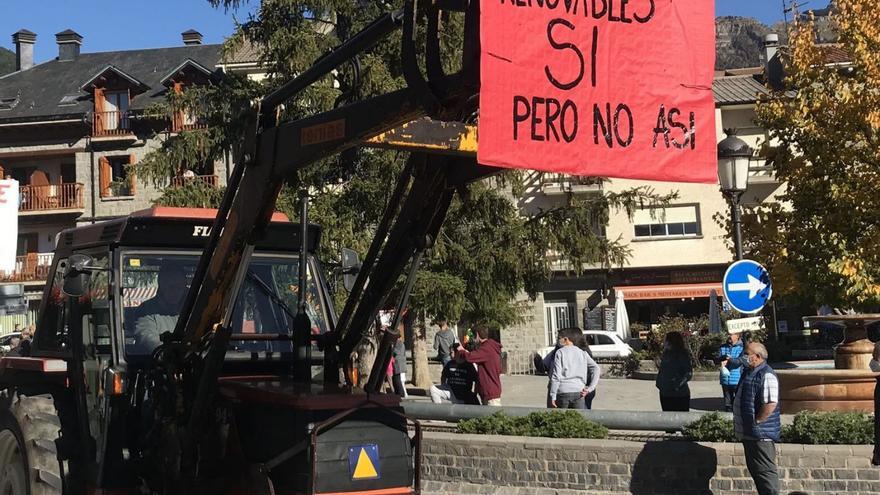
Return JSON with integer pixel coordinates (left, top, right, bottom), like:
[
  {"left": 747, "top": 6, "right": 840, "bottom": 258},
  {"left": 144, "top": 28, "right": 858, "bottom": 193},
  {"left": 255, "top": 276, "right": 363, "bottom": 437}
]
[{"left": 776, "top": 369, "right": 878, "bottom": 414}]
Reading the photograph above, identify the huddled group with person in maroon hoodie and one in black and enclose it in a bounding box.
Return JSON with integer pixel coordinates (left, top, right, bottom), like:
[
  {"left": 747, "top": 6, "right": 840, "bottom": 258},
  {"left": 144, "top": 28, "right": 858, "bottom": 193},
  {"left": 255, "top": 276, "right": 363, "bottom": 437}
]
[{"left": 428, "top": 320, "right": 501, "bottom": 406}]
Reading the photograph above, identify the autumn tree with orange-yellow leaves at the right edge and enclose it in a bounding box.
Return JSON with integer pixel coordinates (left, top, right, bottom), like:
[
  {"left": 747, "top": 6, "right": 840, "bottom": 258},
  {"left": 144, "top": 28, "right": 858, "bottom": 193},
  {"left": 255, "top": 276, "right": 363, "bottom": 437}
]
[{"left": 754, "top": 0, "right": 880, "bottom": 310}]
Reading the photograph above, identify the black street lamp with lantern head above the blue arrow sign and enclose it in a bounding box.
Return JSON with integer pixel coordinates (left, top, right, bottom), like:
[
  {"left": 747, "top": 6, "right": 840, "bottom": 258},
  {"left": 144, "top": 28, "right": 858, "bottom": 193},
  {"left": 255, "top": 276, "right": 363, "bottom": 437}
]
[{"left": 718, "top": 129, "right": 752, "bottom": 260}]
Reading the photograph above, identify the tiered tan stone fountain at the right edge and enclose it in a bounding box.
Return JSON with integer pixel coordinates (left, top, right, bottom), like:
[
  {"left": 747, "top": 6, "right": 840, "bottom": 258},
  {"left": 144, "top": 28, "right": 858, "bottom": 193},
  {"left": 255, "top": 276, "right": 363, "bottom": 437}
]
[{"left": 776, "top": 314, "right": 880, "bottom": 414}]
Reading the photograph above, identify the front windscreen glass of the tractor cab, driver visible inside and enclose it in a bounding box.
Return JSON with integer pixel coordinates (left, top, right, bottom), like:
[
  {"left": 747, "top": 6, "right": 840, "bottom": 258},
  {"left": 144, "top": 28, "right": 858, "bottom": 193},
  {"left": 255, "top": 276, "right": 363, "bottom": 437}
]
[{"left": 122, "top": 253, "right": 327, "bottom": 358}]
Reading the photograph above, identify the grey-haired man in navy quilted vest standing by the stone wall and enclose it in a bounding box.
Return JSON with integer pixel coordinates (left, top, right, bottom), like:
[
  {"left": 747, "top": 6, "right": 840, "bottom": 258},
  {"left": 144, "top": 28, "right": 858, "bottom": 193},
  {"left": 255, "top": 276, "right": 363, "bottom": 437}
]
[{"left": 733, "top": 342, "right": 782, "bottom": 495}]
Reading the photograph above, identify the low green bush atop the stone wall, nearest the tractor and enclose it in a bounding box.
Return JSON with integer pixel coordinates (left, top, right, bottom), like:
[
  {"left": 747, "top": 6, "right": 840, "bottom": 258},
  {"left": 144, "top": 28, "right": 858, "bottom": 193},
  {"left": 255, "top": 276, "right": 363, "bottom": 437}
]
[{"left": 458, "top": 411, "right": 608, "bottom": 439}]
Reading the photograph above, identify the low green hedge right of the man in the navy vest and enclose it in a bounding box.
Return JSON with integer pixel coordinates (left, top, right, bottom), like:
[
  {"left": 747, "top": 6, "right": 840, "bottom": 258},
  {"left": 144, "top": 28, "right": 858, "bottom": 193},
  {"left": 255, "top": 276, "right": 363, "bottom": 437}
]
[{"left": 782, "top": 411, "right": 874, "bottom": 445}]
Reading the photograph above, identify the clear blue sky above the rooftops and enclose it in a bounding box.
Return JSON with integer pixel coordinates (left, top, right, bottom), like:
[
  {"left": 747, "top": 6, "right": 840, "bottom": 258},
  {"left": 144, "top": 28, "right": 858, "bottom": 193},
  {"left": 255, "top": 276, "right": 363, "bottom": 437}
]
[{"left": 0, "top": 0, "right": 827, "bottom": 63}]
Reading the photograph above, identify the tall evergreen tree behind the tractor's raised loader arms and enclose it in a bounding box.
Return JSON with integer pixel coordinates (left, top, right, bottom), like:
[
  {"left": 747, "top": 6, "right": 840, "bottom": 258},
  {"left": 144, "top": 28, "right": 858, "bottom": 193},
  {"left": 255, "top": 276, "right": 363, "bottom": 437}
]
[{"left": 137, "top": 0, "right": 671, "bottom": 387}]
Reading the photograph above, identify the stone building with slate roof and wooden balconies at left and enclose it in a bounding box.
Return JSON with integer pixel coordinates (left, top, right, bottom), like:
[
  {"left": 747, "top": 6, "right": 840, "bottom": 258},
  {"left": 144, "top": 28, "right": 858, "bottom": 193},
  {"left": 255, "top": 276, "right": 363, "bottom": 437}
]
[{"left": 0, "top": 30, "right": 241, "bottom": 322}]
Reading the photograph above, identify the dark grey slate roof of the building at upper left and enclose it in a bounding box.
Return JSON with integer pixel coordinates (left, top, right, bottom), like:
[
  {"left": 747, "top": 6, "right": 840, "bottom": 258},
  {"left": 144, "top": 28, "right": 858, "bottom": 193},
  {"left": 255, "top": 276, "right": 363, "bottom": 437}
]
[{"left": 0, "top": 45, "right": 221, "bottom": 122}]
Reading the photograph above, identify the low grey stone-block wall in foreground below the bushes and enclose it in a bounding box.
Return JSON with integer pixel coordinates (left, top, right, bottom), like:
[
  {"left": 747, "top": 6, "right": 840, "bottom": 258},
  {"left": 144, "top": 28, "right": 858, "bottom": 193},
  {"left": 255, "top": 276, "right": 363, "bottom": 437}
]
[{"left": 422, "top": 433, "right": 880, "bottom": 495}]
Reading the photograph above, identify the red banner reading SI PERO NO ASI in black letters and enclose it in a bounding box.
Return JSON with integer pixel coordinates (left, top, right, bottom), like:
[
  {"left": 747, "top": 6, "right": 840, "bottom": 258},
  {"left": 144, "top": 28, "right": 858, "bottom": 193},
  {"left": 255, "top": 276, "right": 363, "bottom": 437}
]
[{"left": 478, "top": 0, "right": 718, "bottom": 183}]
